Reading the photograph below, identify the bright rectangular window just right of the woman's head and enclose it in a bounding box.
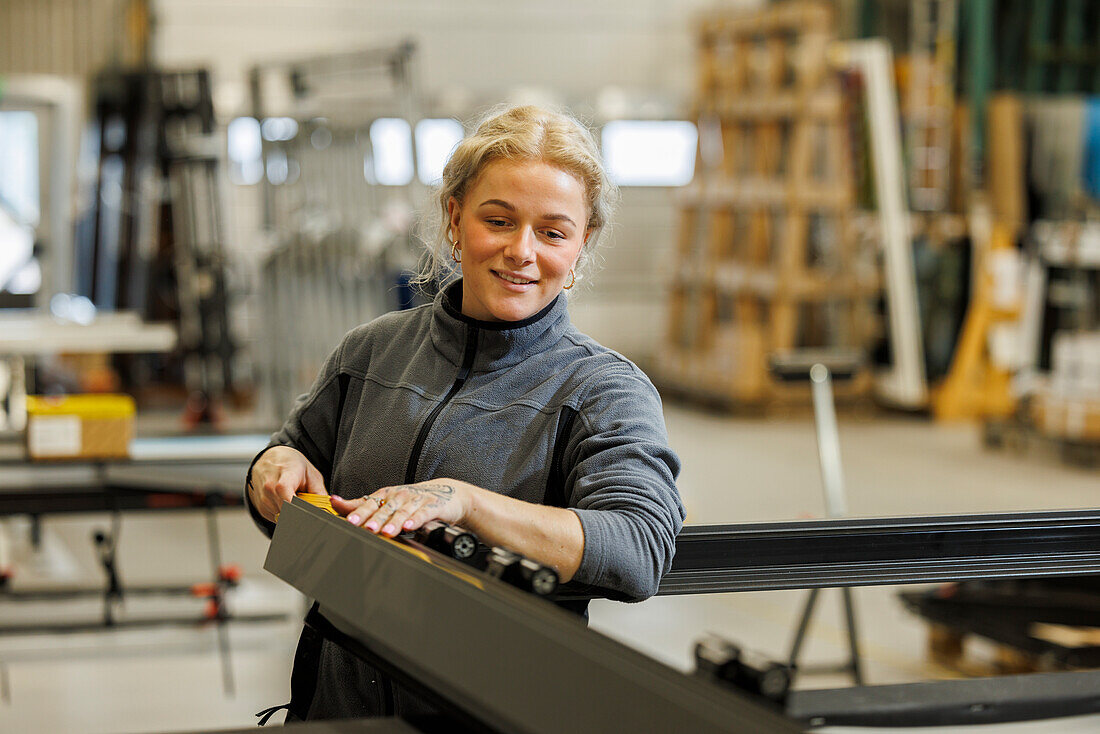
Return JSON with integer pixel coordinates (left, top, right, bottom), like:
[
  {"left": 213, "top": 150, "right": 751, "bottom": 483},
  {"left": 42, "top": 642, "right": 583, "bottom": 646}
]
[{"left": 603, "top": 120, "right": 697, "bottom": 186}]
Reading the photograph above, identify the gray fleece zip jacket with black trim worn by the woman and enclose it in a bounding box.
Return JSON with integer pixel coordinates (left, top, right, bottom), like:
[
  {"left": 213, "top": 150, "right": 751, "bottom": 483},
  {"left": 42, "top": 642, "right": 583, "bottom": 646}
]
[{"left": 250, "top": 282, "right": 684, "bottom": 717}]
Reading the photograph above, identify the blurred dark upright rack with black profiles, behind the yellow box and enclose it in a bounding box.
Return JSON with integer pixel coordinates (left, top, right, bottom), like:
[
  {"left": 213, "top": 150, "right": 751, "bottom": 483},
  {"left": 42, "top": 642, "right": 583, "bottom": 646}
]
[{"left": 76, "top": 69, "right": 235, "bottom": 423}]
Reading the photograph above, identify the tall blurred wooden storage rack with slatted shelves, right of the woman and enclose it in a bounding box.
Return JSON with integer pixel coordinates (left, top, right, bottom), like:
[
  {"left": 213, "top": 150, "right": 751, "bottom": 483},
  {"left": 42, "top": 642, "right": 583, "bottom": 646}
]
[{"left": 653, "top": 0, "right": 881, "bottom": 407}]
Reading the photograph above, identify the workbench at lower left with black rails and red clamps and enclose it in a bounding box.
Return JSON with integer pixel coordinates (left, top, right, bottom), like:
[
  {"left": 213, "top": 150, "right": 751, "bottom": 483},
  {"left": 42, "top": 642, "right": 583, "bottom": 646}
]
[{"left": 0, "top": 434, "right": 285, "bottom": 691}]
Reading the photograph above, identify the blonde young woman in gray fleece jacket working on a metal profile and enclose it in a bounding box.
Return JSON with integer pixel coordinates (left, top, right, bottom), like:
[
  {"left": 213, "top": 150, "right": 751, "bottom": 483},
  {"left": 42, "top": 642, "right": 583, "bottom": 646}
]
[{"left": 248, "top": 107, "right": 684, "bottom": 719}]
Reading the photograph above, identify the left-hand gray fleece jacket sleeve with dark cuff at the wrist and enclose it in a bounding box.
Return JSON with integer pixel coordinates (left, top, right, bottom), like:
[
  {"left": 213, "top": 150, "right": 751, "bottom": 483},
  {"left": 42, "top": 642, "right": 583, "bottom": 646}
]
[{"left": 244, "top": 339, "right": 348, "bottom": 538}]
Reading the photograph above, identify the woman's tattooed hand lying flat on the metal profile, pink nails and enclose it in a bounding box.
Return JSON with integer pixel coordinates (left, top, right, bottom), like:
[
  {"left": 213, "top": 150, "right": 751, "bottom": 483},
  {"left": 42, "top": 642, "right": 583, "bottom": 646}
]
[{"left": 332, "top": 479, "right": 476, "bottom": 538}]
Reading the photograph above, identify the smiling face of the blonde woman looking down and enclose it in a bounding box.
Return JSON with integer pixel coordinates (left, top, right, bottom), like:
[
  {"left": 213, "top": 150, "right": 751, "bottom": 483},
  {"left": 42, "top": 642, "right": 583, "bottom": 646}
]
[{"left": 448, "top": 160, "right": 590, "bottom": 321}]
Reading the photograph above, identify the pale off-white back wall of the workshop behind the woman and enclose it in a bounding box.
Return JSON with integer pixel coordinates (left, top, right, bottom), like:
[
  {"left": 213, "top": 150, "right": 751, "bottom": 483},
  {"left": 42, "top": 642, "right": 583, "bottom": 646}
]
[{"left": 154, "top": 0, "right": 761, "bottom": 361}]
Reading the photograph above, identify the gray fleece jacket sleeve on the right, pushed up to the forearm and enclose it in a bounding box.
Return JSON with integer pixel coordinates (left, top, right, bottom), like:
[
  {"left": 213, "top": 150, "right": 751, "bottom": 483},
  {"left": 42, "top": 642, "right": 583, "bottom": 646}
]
[{"left": 565, "top": 364, "right": 684, "bottom": 601}]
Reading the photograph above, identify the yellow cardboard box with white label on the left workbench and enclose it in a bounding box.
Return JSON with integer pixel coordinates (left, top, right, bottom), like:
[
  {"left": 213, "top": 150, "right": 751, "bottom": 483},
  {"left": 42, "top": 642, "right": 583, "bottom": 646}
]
[{"left": 26, "top": 395, "right": 135, "bottom": 460}]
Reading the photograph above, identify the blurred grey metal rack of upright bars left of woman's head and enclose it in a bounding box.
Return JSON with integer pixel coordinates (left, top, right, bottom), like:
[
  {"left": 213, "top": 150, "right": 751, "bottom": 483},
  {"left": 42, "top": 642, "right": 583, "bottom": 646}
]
[{"left": 251, "top": 43, "right": 427, "bottom": 420}]
